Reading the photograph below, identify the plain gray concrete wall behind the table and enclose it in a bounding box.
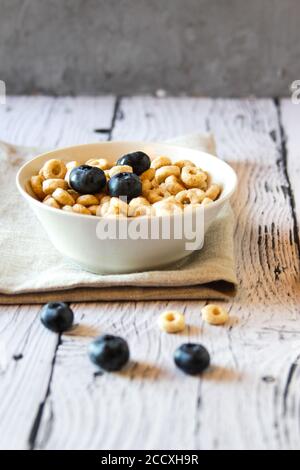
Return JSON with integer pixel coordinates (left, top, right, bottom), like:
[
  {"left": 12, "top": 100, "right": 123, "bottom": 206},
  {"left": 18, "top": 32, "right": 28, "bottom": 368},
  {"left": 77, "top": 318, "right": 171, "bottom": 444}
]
[{"left": 0, "top": 0, "right": 300, "bottom": 96}]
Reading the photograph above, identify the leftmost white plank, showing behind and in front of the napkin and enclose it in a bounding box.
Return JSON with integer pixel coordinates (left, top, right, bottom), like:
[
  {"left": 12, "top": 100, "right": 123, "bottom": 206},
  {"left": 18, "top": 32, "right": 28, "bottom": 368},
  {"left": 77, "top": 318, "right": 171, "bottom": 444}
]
[{"left": 0, "top": 97, "right": 115, "bottom": 449}]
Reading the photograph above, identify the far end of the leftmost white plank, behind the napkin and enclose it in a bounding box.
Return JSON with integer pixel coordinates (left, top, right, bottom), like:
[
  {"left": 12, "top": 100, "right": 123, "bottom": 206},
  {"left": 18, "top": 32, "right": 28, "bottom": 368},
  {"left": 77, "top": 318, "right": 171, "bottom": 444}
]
[{"left": 0, "top": 96, "right": 115, "bottom": 149}]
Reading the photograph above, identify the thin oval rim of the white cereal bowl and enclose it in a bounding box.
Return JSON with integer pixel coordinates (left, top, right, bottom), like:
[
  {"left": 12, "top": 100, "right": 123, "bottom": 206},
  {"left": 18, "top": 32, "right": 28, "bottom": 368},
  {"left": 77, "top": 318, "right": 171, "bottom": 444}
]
[{"left": 16, "top": 140, "right": 238, "bottom": 222}]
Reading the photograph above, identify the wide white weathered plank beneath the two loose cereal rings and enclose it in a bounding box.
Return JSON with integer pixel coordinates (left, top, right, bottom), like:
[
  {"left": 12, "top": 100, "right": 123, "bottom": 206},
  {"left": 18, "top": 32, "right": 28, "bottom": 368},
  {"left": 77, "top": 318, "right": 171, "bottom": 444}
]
[{"left": 31, "top": 97, "right": 300, "bottom": 449}]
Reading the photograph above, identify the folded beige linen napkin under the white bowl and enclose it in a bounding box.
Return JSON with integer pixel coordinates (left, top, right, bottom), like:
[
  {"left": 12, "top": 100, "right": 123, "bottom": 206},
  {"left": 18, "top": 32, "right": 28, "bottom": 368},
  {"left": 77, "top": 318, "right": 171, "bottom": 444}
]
[{"left": 0, "top": 135, "right": 236, "bottom": 304}]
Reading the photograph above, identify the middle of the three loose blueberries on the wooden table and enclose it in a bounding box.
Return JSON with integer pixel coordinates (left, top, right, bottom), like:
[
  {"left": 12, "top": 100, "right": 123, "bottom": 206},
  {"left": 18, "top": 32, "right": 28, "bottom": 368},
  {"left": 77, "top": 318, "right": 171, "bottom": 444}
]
[{"left": 89, "top": 335, "right": 129, "bottom": 372}]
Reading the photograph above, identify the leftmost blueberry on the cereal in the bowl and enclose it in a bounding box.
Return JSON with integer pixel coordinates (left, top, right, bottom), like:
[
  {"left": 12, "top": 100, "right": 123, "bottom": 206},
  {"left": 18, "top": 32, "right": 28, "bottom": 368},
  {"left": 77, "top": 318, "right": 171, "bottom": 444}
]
[{"left": 69, "top": 165, "right": 106, "bottom": 194}]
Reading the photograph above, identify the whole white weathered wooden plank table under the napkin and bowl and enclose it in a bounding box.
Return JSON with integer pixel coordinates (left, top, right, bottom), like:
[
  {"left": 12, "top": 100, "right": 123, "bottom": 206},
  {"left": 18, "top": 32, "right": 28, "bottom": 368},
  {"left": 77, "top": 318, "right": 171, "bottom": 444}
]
[{"left": 0, "top": 97, "right": 300, "bottom": 449}]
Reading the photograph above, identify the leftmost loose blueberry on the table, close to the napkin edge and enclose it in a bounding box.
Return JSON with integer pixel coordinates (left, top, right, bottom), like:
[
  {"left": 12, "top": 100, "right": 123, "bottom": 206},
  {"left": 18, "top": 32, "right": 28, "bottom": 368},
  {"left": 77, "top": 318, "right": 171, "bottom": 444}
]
[{"left": 41, "top": 302, "right": 74, "bottom": 333}]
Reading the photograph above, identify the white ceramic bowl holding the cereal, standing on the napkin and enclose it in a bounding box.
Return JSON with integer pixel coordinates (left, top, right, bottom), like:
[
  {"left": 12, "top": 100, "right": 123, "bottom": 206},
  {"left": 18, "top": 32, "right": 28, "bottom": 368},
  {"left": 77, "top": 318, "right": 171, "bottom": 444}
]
[{"left": 17, "top": 142, "right": 237, "bottom": 273}]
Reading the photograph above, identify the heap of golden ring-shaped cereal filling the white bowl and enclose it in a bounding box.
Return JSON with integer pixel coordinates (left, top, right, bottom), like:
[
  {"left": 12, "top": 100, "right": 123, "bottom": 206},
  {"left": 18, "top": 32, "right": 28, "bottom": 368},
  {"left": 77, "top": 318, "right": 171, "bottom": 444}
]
[{"left": 29, "top": 152, "right": 222, "bottom": 217}]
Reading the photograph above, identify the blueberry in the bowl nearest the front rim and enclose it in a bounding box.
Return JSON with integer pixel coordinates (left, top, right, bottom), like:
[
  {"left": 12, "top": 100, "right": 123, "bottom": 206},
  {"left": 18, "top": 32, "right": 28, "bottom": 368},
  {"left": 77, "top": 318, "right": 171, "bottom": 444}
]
[{"left": 108, "top": 173, "right": 142, "bottom": 201}]
